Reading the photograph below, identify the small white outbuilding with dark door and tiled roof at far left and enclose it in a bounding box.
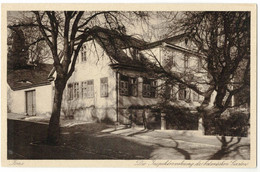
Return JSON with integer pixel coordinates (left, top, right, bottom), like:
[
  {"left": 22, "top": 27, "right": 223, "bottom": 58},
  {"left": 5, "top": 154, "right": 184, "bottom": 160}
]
[{"left": 7, "top": 64, "right": 53, "bottom": 115}]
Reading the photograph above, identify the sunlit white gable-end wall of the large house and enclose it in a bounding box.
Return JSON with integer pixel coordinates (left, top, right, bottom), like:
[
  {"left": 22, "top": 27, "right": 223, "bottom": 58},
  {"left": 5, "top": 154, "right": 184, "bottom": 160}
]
[{"left": 62, "top": 41, "right": 116, "bottom": 120}]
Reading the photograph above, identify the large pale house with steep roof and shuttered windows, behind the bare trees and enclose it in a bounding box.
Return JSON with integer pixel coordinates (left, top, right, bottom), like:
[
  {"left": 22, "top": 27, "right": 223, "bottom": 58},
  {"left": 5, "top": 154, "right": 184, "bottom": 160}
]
[{"left": 59, "top": 27, "right": 205, "bottom": 124}]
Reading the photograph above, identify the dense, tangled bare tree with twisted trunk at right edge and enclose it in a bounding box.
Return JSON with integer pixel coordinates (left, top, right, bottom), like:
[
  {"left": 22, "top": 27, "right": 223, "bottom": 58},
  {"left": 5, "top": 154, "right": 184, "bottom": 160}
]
[{"left": 149, "top": 12, "right": 250, "bottom": 136}]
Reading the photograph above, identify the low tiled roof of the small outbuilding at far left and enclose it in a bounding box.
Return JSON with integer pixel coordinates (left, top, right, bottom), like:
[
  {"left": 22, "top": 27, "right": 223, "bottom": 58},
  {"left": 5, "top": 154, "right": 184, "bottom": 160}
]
[{"left": 7, "top": 64, "right": 53, "bottom": 90}]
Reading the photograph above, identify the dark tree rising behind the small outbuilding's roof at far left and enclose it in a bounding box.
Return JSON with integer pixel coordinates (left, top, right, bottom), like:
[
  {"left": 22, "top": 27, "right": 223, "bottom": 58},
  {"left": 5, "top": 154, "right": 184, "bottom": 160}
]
[{"left": 7, "top": 14, "right": 50, "bottom": 70}]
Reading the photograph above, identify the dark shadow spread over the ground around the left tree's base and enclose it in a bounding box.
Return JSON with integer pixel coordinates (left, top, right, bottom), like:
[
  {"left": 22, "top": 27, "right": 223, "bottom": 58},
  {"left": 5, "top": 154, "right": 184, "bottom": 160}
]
[{"left": 8, "top": 120, "right": 153, "bottom": 159}]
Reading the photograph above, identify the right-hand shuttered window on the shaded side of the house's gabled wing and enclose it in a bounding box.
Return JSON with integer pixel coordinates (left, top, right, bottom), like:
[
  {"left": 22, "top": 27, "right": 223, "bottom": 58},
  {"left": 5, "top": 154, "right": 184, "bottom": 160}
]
[{"left": 143, "top": 78, "right": 157, "bottom": 98}]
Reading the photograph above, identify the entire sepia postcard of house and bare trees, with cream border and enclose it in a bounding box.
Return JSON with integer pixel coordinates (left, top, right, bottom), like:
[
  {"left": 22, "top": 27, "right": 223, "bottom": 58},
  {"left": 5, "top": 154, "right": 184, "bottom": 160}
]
[{"left": 1, "top": 4, "right": 256, "bottom": 167}]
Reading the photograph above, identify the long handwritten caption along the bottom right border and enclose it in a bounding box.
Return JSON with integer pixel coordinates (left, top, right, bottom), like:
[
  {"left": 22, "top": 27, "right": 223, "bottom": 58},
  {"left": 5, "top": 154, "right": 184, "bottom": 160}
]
[{"left": 134, "top": 160, "right": 248, "bottom": 168}]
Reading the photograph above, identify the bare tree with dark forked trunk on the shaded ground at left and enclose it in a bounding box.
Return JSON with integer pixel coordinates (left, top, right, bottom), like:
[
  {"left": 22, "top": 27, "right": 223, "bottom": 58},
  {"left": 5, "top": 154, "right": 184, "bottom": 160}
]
[{"left": 12, "top": 11, "right": 145, "bottom": 144}]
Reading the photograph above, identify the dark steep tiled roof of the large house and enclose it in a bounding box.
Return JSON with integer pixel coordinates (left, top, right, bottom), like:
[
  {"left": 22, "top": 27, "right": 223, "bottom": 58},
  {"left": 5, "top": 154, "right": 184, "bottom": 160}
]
[{"left": 93, "top": 27, "right": 187, "bottom": 68}]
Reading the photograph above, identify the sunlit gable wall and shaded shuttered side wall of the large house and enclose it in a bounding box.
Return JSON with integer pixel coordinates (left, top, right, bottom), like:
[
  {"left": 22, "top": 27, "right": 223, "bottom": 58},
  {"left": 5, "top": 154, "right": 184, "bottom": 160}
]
[{"left": 62, "top": 32, "right": 158, "bottom": 124}]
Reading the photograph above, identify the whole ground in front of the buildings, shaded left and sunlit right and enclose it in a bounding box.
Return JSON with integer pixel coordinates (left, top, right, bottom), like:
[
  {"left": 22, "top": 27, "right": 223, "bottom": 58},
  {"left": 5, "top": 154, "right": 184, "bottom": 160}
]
[{"left": 8, "top": 114, "right": 250, "bottom": 160}]
